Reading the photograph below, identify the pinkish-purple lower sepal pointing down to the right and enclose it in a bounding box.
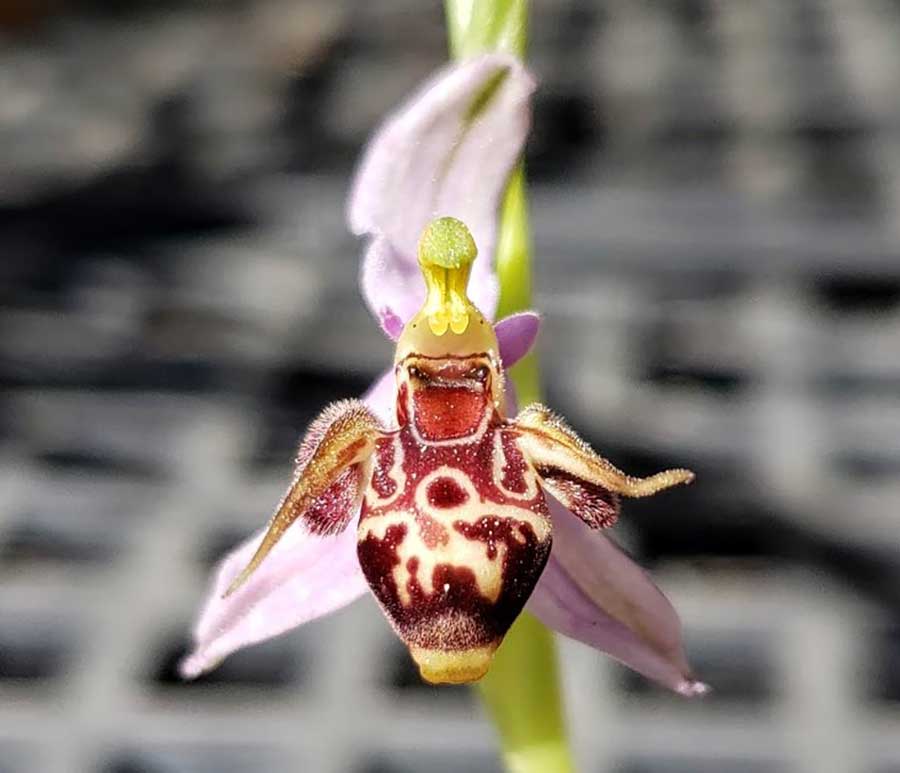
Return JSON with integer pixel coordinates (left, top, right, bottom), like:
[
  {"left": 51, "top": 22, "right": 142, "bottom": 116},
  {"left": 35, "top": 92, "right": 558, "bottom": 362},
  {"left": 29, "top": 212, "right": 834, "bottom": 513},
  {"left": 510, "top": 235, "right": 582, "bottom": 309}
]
[{"left": 528, "top": 498, "right": 708, "bottom": 697}]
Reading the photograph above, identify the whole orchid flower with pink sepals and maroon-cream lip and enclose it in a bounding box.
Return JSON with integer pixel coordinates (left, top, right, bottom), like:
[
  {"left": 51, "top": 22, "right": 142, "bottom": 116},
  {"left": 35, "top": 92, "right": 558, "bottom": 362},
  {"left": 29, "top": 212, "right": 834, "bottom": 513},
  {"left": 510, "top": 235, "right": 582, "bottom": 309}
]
[{"left": 181, "top": 55, "right": 706, "bottom": 695}]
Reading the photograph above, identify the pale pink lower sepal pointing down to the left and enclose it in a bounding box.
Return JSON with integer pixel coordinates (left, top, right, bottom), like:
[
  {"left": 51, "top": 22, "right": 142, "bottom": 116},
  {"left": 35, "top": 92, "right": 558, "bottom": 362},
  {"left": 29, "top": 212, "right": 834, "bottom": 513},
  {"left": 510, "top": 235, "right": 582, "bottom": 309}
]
[{"left": 179, "top": 522, "right": 368, "bottom": 679}]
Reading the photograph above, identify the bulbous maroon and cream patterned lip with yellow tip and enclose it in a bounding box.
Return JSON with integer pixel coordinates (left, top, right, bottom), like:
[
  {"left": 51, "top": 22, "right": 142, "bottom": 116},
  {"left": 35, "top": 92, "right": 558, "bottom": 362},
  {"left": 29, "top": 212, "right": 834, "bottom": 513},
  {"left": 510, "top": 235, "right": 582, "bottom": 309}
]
[{"left": 358, "top": 368, "right": 551, "bottom": 681}]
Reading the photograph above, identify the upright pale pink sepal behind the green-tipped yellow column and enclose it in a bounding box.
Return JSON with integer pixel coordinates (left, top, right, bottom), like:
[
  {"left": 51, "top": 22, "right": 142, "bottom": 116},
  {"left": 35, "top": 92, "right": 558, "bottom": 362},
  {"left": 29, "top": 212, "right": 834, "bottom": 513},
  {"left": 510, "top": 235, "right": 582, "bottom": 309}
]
[{"left": 347, "top": 54, "right": 535, "bottom": 322}]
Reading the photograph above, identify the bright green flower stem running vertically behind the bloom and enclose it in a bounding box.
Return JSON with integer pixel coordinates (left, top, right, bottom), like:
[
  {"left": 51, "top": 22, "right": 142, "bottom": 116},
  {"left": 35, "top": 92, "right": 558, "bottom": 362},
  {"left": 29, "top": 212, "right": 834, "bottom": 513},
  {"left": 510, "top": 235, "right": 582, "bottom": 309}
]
[{"left": 445, "top": 0, "right": 575, "bottom": 773}]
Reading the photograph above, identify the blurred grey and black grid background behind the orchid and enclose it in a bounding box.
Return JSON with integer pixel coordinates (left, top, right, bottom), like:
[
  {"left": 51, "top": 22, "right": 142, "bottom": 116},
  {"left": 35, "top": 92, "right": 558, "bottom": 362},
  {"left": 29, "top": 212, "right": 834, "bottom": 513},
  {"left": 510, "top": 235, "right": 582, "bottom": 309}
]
[{"left": 0, "top": 0, "right": 900, "bottom": 773}]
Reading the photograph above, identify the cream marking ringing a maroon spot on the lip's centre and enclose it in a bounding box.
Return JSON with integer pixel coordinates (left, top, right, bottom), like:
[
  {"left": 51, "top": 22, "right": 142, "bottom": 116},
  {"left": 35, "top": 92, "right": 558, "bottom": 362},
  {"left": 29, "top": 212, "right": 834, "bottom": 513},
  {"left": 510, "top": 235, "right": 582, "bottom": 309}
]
[{"left": 358, "top": 465, "right": 550, "bottom": 606}]
